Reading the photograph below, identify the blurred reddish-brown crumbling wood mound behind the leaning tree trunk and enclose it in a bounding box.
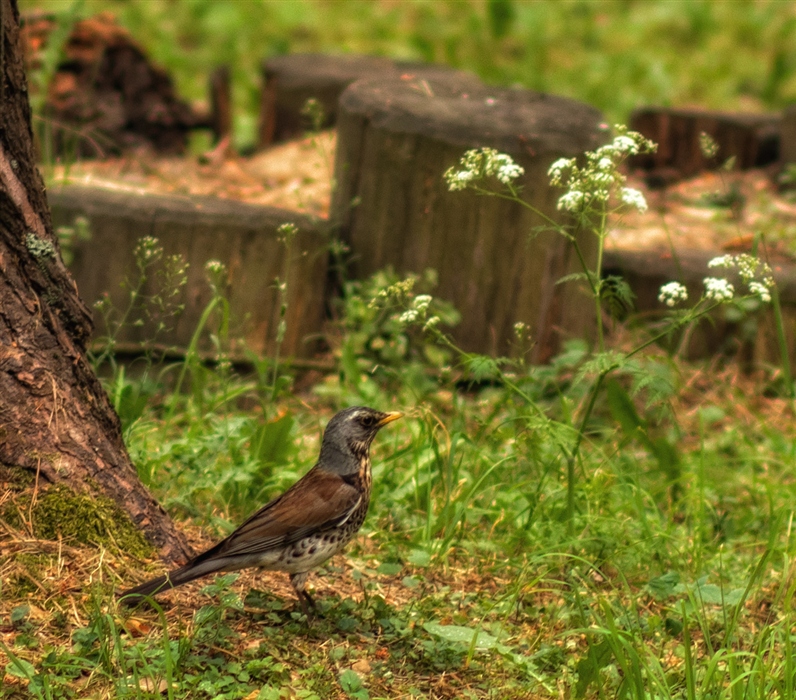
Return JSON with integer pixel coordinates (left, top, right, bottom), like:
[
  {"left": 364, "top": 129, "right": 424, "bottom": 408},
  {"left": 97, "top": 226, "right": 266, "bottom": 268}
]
[{"left": 22, "top": 14, "right": 204, "bottom": 158}]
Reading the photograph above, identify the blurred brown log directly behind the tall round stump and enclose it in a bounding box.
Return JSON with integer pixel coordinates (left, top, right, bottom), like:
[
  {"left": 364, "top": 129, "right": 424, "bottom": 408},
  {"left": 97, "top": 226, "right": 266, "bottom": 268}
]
[{"left": 257, "top": 53, "right": 476, "bottom": 149}]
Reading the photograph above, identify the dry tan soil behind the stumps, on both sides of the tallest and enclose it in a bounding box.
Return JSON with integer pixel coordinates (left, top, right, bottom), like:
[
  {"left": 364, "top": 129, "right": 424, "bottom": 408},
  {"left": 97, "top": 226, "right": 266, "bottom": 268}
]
[{"left": 46, "top": 131, "right": 796, "bottom": 262}]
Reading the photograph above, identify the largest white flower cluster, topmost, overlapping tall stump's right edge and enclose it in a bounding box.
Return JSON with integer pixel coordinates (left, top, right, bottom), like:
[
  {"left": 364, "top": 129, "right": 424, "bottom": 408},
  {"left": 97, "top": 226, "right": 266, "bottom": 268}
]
[{"left": 547, "top": 127, "right": 655, "bottom": 213}]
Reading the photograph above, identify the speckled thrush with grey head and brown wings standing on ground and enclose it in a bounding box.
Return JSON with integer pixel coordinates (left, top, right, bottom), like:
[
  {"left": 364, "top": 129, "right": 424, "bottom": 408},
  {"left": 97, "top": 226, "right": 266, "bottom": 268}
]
[{"left": 119, "top": 406, "right": 403, "bottom": 619}]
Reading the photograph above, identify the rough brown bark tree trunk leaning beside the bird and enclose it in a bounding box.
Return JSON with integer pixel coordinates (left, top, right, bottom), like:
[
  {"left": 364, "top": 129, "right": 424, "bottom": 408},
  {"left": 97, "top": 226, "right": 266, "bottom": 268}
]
[{"left": 0, "top": 0, "right": 189, "bottom": 562}]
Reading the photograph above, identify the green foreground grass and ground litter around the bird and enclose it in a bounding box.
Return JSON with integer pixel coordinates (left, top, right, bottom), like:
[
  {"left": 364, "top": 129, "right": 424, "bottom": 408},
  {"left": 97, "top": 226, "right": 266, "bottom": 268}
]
[{"left": 0, "top": 326, "right": 796, "bottom": 698}]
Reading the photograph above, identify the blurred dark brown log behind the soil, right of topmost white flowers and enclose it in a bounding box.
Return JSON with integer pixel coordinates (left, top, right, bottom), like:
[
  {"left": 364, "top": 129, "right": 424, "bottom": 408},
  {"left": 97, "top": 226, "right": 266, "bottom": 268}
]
[{"left": 630, "top": 107, "right": 780, "bottom": 179}]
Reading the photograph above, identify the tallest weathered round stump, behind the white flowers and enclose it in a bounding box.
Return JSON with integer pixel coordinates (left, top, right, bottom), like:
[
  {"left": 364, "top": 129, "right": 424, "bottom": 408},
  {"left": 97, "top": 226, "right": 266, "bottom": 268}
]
[{"left": 332, "top": 77, "right": 605, "bottom": 361}]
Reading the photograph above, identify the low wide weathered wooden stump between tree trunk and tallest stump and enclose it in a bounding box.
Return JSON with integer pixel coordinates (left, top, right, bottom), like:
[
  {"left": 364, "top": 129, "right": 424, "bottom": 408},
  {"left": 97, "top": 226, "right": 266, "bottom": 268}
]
[{"left": 48, "top": 186, "right": 328, "bottom": 357}]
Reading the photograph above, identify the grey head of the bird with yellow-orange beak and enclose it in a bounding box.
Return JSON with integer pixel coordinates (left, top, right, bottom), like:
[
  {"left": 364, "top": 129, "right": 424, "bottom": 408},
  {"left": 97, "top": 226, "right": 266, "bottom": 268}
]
[{"left": 318, "top": 406, "right": 403, "bottom": 475}]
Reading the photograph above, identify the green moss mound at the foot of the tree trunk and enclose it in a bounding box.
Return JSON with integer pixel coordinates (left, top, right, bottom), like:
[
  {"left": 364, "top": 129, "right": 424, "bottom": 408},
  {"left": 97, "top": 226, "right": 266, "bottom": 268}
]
[{"left": 0, "top": 486, "right": 153, "bottom": 557}]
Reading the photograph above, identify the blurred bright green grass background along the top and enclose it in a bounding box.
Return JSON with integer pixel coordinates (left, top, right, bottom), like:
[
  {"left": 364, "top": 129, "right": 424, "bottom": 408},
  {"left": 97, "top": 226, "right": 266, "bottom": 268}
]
[{"left": 20, "top": 0, "right": 796, "bottom": 146}]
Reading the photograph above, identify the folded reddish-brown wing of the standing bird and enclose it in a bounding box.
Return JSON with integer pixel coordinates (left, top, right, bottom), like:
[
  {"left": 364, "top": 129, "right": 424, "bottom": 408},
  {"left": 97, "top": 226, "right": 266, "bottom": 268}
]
[{"left": 194, "top": 469, "right": 362, "bottom": 563}]
